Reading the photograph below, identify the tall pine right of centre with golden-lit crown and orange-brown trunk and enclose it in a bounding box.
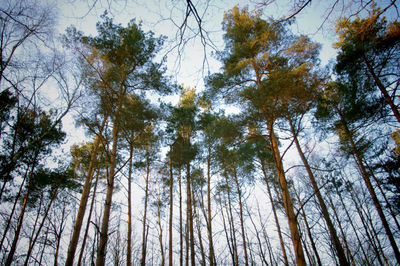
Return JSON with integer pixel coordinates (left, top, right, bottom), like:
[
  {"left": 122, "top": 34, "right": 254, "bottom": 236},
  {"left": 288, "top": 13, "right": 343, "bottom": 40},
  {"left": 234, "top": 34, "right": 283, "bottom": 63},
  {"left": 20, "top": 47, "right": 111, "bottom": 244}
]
[{"left": 209, "top": 7, "right": 306, "bottom": 265}]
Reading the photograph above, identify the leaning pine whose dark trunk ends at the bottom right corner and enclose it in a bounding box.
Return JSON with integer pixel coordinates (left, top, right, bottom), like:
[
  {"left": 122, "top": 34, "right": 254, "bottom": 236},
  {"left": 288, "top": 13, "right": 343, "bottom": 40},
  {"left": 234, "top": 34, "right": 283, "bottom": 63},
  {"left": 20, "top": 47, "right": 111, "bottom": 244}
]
[{"left": 316, "top": 80, "right": 400, "bottom": 262}]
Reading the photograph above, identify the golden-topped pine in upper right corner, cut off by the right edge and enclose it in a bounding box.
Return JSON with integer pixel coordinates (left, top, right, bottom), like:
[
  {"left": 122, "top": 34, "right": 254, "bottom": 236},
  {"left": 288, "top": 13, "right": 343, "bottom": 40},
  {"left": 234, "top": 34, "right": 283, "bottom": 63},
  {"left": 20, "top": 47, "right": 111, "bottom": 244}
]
[{"left": 335, "top": 9, "right": 400, "bottom": 123}]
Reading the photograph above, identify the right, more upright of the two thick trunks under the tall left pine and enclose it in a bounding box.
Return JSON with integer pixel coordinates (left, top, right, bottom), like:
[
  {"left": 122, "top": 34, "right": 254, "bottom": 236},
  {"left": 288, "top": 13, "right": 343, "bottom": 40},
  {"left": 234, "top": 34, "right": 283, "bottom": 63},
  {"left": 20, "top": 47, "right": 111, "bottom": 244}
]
[{"left": 96, "top": 114, "right": 121, "bottom": 266}]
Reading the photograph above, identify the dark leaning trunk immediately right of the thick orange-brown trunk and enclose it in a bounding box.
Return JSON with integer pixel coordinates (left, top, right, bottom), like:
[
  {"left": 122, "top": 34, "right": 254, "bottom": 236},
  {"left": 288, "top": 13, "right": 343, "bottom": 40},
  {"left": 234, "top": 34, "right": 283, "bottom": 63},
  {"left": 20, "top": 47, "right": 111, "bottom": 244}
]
[{"left": 288, "top": 117, "right": 350, "bottom": 266}]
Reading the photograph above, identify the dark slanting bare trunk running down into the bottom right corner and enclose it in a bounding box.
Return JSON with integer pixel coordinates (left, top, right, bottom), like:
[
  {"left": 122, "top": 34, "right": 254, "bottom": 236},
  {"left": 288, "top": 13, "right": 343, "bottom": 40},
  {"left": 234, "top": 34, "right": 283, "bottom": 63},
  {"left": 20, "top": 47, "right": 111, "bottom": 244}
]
[{"left": 342, "top": 116, "right": 400, "bottom": 264}]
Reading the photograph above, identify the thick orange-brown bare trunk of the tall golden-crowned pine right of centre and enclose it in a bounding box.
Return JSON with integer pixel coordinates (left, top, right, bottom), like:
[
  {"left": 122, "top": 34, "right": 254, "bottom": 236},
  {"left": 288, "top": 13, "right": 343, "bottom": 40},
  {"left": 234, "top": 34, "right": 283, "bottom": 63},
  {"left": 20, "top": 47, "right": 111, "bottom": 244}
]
[{"left": 267, "top": 120, "right": 306, "bottom": 266}]
